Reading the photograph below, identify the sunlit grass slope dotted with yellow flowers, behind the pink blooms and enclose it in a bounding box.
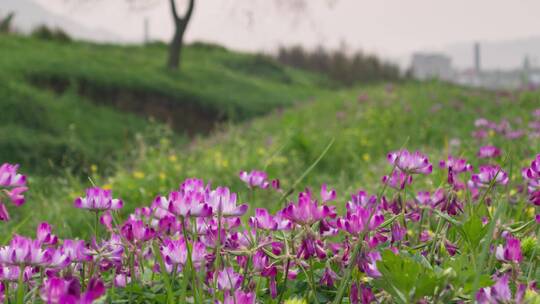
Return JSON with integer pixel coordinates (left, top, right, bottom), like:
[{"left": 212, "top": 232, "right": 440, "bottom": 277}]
[{"left": 10, "top": 83, "right": 540, "bottom": 235}]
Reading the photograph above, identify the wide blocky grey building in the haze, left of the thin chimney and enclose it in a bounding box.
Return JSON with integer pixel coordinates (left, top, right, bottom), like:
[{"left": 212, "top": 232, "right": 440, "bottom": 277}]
[{"left": 411, "top": 53, "right": 452, "bottom": 80}]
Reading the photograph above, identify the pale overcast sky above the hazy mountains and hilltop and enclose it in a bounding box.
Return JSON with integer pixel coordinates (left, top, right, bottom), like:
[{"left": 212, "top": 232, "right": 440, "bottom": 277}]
[{"left": 35, "top": 0, "right": 540, "bottom": 56}]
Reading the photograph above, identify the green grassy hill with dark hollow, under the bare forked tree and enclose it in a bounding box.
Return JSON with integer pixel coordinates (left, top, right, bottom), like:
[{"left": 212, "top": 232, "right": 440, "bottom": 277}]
[{"left": 0, "top": 35, "right": 330, "bottom": 174}]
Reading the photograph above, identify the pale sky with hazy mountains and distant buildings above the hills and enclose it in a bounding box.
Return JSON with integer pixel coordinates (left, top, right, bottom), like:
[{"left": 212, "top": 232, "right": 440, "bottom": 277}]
[{"left": 4, "top": 0, "right": 540, "bottom": 88}]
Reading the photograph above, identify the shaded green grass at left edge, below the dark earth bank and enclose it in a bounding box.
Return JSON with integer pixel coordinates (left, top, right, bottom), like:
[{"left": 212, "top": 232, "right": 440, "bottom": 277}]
[{"left": 0, "top": 73, "right": 160, "bottom": 175}]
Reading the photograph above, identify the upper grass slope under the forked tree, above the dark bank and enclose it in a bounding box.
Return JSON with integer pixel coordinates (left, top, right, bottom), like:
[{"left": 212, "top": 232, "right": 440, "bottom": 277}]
[{"left": 0, "top": 36, "right": 330, "bottom": 119}]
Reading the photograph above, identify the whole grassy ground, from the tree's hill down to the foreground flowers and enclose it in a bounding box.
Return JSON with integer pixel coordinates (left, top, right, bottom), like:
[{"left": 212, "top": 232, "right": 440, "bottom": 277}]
[{"left": 0, "top": 37, "right": 540, "bottom": 304}]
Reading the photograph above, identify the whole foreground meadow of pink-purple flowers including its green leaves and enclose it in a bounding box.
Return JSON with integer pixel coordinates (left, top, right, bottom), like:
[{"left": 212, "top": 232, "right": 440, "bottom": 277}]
[{"left": 0, "top": 110, "right": 540, "bottom": 304}]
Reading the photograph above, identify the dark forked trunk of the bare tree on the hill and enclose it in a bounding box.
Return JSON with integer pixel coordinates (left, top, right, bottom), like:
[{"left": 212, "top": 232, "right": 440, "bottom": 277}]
[{"left": 167, "top": 0, "right": 195, "bottom": 70}]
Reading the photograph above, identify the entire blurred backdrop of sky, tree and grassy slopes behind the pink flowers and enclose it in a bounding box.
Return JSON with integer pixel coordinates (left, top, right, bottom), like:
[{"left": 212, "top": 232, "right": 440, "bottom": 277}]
[{"left": 0, "top": 0, "right": 540, "bottom": 234}]
